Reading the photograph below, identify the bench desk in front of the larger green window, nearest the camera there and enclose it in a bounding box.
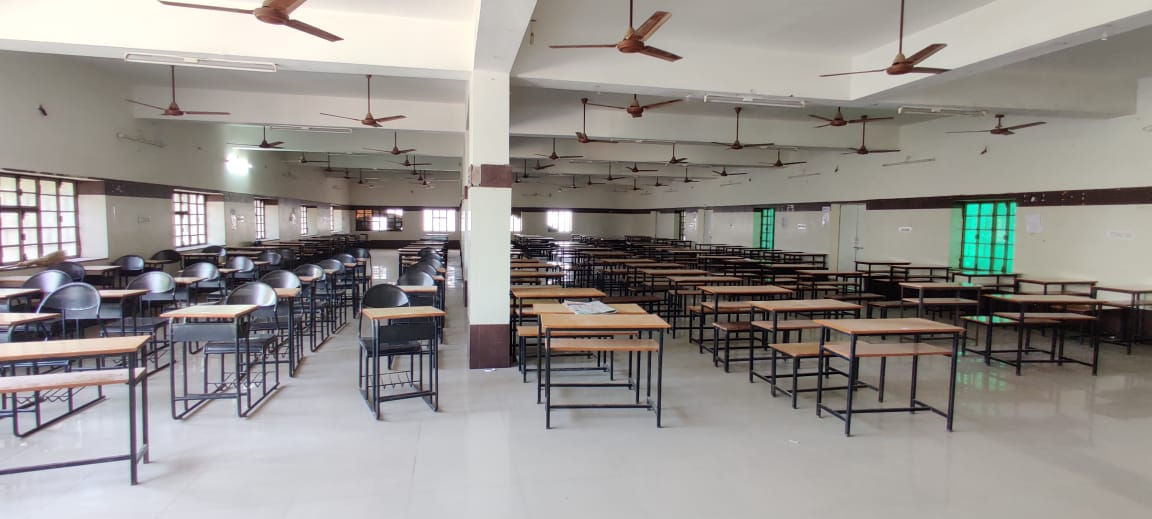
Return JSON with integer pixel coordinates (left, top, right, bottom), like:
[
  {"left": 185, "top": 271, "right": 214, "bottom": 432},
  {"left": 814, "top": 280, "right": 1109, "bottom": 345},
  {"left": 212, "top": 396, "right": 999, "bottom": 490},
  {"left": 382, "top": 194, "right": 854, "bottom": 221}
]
[{"left": 984, "top": 293, "right": 1107, "bottom": 375}]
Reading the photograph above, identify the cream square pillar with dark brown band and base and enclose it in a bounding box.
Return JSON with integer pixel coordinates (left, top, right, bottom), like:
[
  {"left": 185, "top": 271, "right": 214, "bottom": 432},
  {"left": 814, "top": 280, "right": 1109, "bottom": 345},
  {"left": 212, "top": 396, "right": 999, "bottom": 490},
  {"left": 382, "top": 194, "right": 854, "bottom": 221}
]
[{"left": 461, "top": 70, "right": 513, "bottom": 369}]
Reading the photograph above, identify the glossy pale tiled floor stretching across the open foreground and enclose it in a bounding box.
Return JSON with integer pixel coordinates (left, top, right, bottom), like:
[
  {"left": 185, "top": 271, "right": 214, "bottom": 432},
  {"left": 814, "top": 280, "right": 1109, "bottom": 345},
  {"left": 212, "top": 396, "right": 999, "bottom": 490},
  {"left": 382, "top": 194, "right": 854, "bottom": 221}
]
[{"left": 0, "top": 250, "right": 1152, "bottom": 519}]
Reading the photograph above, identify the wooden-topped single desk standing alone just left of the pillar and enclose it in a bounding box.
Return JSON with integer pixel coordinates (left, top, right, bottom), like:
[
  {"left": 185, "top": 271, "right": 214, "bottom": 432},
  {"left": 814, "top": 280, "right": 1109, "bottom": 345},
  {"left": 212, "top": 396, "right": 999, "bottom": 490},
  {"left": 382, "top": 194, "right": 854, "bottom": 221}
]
[{"left": 357, "top": 306, "right": 446, "bottom": 420}]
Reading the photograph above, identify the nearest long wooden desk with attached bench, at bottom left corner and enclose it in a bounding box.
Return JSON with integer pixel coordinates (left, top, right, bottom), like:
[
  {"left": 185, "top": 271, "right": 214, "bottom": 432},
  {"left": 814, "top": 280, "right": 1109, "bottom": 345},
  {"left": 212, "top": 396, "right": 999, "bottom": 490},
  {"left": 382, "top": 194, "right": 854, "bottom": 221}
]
[{"left": 0, "top": 335, "right": 151, "bottom": 484}]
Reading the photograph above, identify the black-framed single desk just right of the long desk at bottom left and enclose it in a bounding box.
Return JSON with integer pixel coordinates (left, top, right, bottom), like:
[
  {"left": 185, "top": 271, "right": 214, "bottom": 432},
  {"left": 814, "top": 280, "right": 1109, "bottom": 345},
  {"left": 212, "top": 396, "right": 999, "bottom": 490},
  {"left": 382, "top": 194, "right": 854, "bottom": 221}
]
[{"left": 160, "top": 305, "right": 280, "bottom": 420}]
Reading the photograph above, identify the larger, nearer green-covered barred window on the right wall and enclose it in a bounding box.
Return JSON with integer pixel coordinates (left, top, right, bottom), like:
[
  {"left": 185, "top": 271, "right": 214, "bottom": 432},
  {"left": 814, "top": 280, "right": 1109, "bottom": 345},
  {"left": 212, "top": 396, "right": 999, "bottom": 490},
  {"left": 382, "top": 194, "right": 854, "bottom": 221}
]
[{"left": 960, "top": 200, "right": 1016, "bottom": 273}]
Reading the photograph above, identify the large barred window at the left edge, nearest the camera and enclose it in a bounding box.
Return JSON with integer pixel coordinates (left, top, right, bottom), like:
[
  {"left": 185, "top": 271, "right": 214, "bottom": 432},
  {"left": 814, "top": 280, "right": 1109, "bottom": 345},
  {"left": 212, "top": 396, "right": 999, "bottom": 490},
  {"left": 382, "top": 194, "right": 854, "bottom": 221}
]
[{"left": 0, "top": 175, "right": 79, "bottom": 264}]
